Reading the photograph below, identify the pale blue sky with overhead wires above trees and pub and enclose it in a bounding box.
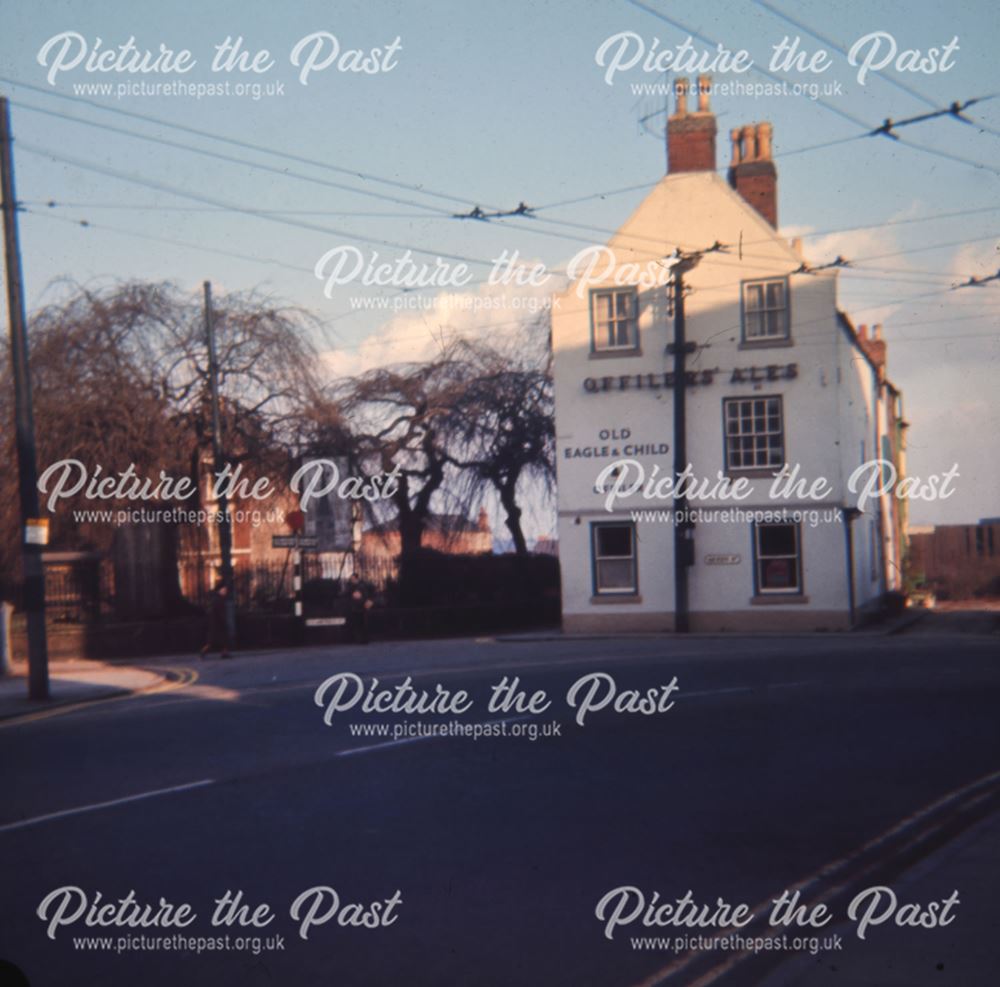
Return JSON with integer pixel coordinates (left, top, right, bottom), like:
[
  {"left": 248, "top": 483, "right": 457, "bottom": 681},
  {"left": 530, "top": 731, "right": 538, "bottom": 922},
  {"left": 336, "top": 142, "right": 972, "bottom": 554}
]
[{"left": 0, "top": 0, "right": 1000, "bottom": 521}]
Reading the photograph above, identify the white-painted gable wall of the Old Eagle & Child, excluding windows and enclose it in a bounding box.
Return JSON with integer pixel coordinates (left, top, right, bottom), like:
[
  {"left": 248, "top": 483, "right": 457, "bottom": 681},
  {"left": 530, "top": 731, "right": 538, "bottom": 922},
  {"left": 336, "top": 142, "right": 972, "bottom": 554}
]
[{"left": 552, "top": 172, "right": 900, "bottom": 622}]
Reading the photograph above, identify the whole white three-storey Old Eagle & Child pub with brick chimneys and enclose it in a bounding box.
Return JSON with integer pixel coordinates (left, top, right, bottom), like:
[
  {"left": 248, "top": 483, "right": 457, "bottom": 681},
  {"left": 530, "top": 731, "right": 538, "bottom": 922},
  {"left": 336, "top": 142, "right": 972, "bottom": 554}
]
[{"left": 552, "top": 77, "right": 906, "bottom": 632}]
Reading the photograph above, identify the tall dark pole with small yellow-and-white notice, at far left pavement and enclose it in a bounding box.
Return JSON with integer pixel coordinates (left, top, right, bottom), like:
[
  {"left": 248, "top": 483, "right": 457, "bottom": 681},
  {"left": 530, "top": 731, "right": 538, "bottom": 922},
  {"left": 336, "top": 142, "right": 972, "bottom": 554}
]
[{"left": 0, "top": 96, "right": 49, "bottom": 700}]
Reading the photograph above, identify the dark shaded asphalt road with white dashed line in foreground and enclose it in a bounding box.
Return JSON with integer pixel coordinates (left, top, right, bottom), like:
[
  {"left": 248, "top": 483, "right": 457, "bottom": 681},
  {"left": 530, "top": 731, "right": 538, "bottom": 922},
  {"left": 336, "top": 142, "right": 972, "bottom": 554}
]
[{"left": 0, "top": 635, "right": 1000, "bottom": 987}]
